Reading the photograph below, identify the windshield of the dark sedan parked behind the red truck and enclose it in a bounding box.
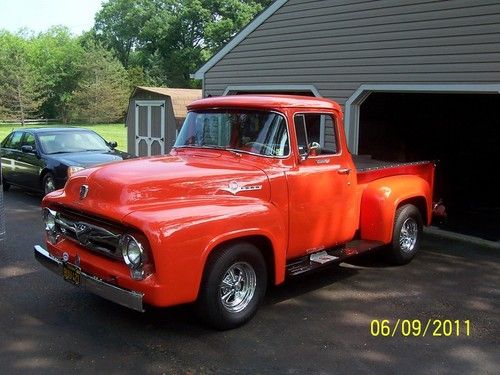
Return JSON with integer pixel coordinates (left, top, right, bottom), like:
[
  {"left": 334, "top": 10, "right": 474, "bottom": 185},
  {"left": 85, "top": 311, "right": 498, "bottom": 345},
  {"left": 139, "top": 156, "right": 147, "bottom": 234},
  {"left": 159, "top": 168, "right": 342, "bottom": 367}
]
[{"left": 38, "top": 130, "right": 110, "bottom": 154}]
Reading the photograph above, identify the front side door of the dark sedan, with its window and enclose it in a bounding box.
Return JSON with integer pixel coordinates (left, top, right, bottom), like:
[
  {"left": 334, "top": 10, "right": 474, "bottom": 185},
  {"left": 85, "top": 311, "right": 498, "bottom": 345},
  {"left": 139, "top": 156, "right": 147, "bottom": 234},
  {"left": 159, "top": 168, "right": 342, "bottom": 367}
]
[{"left": 16, "top": 132, "right": 43, "bottom": 189}]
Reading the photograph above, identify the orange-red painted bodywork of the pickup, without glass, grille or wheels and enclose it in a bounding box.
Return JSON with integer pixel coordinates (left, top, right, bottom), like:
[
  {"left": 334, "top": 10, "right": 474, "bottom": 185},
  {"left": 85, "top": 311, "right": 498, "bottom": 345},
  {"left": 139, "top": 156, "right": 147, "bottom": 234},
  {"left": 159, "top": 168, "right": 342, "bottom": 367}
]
[{"left": 42, "top": 95, "right": 434, "bottom": 306}]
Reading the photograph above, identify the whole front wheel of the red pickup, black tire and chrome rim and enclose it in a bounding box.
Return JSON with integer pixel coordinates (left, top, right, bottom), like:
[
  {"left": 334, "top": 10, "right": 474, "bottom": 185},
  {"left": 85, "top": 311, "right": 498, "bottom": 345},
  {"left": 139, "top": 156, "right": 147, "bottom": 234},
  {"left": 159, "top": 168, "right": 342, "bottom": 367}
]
[{"left": 197, "top": 242, "right": 267, "bottom": 330}]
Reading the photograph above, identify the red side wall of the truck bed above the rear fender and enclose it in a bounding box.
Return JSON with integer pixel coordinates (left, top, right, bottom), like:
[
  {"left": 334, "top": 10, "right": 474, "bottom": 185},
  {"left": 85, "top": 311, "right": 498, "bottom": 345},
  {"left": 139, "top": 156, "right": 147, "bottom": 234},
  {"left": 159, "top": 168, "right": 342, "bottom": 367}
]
[{"left": 352, "top": 155, "right": 434, "bottom": 186}]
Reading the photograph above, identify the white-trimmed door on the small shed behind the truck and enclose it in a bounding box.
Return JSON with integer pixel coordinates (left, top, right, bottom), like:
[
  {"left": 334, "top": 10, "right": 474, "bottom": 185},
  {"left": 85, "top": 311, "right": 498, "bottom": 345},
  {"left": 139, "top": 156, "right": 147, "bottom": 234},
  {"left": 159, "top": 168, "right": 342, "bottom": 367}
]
[{"left": 135, "top": 100, "right": 165, "bottom": 156}]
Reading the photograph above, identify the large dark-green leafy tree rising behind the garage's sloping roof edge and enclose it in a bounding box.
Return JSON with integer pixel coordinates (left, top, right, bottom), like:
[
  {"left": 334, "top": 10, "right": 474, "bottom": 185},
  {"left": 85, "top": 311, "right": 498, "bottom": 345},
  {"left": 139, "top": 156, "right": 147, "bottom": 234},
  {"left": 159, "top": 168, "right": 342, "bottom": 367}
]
[{"left": 94, "top": 0, "right": 271, "bottom": 87}]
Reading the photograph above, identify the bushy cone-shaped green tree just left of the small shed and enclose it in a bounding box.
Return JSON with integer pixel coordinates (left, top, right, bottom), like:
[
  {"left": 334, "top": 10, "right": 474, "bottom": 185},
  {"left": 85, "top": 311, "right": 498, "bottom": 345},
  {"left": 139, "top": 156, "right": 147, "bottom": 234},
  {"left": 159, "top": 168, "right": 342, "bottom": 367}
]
[{"left": 70, "top": 44, "right": 129, "bottom": 123}]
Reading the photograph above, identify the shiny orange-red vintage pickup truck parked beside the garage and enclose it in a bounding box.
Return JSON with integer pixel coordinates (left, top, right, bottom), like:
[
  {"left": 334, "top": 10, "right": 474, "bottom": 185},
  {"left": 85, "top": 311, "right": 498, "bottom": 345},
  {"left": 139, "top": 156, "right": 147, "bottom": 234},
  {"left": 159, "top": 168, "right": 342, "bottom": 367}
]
[{"left": 34, "top": 95, "right": 434, "bottom": 329}]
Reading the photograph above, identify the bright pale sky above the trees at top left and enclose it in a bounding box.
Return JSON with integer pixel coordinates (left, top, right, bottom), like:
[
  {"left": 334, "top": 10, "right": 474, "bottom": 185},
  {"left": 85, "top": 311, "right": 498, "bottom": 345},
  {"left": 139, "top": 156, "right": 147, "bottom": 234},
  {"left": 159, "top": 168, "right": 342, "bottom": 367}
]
[{"left": 0, "top": 0, "right": 103, "bottom": 35}]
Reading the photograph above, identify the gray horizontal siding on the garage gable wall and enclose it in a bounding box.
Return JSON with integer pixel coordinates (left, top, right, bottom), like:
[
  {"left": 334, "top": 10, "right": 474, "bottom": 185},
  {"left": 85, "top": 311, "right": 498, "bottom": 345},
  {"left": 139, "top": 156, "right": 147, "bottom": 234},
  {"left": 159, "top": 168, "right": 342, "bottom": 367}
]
[{"left": 204, "top": 0, "right": 500, "bottom": 104}]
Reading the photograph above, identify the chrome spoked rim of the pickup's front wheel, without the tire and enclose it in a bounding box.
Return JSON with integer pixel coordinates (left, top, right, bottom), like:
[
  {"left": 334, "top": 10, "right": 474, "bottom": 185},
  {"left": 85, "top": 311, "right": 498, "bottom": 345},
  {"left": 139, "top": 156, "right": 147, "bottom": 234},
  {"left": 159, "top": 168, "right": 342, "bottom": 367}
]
[{"left": 219, "top": 262, "right": 257, "bottom": 313}]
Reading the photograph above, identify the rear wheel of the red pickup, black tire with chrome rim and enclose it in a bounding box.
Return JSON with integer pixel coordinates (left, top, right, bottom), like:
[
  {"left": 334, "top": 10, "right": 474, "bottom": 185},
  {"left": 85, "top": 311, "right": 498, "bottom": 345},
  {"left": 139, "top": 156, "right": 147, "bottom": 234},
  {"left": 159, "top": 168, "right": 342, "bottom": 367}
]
[{"left": 389, "top": 204, "right": 423, "bottom": 264}]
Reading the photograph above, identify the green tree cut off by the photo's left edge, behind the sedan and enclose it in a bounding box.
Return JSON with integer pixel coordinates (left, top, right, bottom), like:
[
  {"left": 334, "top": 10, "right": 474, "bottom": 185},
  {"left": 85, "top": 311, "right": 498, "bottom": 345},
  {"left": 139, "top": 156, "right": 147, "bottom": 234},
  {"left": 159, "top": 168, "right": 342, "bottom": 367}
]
[{"left": 0, "top": 31, "right": 45, "bottom": 125}]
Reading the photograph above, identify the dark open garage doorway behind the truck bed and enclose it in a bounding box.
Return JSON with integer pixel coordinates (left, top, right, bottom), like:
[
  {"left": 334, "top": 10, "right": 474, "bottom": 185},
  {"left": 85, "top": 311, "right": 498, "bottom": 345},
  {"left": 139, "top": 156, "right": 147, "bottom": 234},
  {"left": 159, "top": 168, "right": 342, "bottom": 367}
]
[{"left": 358, "top": 92, "right": 500, "bottom": 241}]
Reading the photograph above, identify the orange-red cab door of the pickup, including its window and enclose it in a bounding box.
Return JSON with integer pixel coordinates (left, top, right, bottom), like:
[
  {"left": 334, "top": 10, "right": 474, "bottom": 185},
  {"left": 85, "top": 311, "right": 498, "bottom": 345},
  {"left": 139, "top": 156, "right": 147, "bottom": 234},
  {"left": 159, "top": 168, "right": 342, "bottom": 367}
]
[{"left": 287, "top": 112, "right": 358, "bottom": 259}]
